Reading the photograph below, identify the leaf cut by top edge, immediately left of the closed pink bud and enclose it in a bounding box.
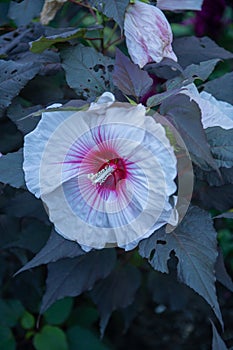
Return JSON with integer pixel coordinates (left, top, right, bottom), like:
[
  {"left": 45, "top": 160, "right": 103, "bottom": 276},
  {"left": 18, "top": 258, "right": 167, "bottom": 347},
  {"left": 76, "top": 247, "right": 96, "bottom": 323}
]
[{"left": 89, "top": 0, "right": 130, "bottom": 30}]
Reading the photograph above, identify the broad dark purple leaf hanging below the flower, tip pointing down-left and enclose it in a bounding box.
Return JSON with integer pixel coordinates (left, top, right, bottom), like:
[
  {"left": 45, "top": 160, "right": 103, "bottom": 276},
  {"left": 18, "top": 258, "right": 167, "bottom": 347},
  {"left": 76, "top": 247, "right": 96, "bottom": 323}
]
[{"left": 40, "top": 249, "right": 116, "bottom": 313}]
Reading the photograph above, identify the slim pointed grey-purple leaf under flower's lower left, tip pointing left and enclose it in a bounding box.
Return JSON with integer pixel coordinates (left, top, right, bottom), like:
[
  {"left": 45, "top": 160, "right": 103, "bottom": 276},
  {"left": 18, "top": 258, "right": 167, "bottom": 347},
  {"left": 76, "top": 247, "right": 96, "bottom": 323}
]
[{"left": 17, "top": 229, "right": 85, "bottom": 274}]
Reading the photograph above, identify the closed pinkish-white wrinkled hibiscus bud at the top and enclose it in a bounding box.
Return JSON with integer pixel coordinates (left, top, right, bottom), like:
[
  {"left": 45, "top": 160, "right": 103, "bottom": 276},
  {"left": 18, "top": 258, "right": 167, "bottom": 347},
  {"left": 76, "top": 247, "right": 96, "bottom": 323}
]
[{"left": 124, "top": 1, "right": 177, "bottom": 68}]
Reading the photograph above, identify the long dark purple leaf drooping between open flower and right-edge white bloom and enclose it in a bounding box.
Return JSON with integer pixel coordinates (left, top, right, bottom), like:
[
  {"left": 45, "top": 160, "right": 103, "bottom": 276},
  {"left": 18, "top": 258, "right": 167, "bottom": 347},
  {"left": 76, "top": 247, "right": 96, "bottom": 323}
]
[{"left": 160, "top": 94, "right": 218, "bottom": 171}]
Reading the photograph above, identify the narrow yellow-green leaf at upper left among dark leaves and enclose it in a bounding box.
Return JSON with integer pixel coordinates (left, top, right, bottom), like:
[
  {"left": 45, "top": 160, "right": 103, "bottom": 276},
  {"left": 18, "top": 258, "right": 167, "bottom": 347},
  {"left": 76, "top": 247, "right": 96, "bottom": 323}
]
[{"left": 30, "top": 27, "right": 89, "bottom": 53}]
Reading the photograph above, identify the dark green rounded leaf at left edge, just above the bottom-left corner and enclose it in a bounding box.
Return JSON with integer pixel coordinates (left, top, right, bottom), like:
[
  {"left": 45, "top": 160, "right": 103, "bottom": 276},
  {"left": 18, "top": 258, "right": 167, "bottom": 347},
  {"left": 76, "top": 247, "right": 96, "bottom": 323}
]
[{"left": 0, "top": 299, "right": 24, "bottom": 327}]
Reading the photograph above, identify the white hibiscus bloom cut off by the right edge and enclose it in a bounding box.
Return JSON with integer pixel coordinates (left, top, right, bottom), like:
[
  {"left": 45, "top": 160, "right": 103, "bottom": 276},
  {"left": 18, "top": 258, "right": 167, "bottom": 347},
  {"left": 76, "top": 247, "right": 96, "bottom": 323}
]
[{"left": 182, "top": 84, "right": 233, "bottom": 130}]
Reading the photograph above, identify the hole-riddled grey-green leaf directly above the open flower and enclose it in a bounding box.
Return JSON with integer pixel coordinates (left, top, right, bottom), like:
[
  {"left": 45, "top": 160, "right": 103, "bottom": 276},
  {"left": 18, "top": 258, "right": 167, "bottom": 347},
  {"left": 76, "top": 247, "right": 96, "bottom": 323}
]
[{"left": 61, "top": 45, "right": 113, "bottom": 98}]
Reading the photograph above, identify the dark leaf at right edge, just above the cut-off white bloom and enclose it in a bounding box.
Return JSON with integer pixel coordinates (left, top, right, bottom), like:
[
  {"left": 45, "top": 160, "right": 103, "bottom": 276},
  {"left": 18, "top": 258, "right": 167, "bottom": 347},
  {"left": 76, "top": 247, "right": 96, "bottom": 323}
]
[{"left": 204, "top": 72, "right": 233, "bottom": 104}]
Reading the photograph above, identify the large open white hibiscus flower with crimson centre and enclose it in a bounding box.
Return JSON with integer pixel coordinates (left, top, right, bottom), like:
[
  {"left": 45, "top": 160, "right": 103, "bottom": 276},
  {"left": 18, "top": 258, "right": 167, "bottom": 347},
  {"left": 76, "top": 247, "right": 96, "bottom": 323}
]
[{"left": 23, "top": 93, "right": 176, "bottom": 250}]
